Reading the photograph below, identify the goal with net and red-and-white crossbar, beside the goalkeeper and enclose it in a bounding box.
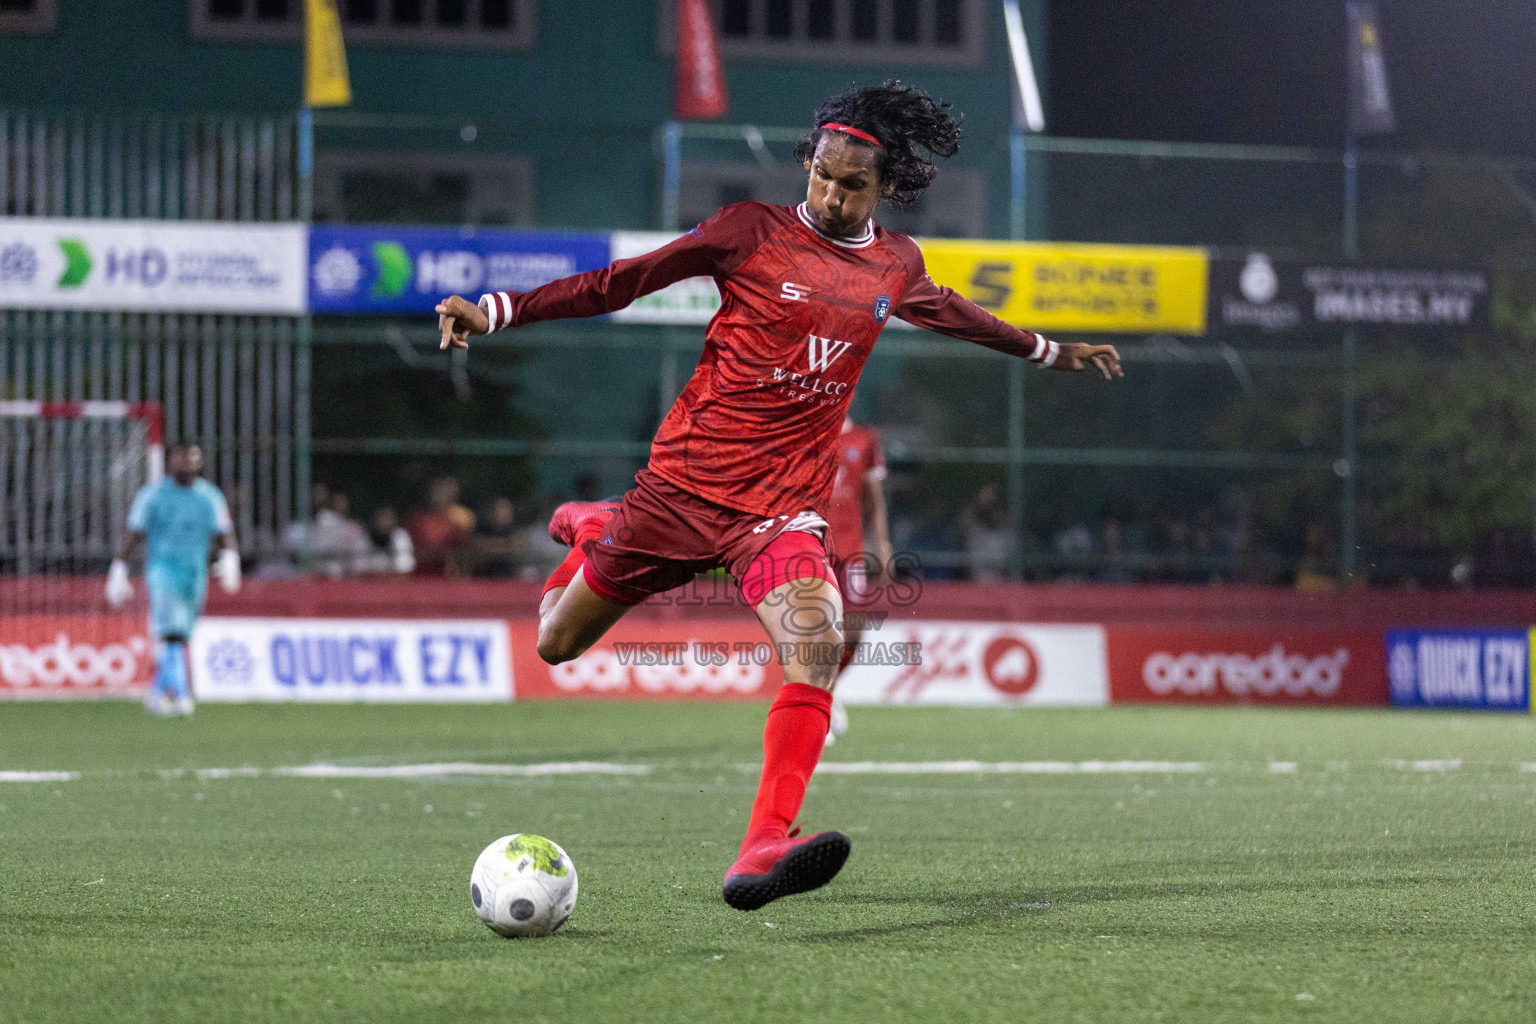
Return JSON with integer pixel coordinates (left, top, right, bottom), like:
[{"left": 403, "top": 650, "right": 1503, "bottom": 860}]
[{"left": 0, "top": 401, "right": 164, "bottom": 699}]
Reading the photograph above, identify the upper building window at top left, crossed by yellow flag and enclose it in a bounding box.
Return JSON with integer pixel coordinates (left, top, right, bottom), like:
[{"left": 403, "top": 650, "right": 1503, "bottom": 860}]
[{"left": 192, "top": 0, "right": 535, "bottom": 49}]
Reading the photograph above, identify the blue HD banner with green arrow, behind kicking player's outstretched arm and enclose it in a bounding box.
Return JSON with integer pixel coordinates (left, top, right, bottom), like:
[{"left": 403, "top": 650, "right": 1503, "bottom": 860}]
[{"left": 309, "top": 224, "right": 608, "bottom": 315}]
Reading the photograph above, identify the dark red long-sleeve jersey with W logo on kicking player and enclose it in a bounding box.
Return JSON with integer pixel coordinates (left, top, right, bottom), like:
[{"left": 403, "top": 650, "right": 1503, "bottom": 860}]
[{"left": 481, "top": 203, "right": 1057, "bottom": 516}]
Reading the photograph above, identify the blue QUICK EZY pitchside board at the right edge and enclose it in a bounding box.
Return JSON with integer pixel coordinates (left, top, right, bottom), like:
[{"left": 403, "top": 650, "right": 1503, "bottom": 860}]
[{"left": 1387, "top": 629, "right": 1531, "bottom": 711}]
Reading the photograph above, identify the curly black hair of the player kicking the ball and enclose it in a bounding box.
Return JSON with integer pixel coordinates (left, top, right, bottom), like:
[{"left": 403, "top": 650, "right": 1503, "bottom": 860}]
[{"left": 794, "top": 78, "right": 960, "bottom": 206}]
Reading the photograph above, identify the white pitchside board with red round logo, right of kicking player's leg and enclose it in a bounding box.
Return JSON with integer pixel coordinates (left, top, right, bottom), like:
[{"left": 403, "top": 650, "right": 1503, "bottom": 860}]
[{"left": 837, "top": 619, "right": 1109, "bottom": 708}]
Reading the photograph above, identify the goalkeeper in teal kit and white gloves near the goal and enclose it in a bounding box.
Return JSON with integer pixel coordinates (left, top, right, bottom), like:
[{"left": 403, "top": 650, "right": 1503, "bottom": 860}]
[{"left": 106, "top": 445, "right": 240, "bottom": 715}]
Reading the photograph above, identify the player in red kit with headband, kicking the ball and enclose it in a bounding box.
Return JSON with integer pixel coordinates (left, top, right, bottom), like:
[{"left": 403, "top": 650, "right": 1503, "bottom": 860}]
[{"left": 438, "top": 81, "right": 1121, "bottom": 910}]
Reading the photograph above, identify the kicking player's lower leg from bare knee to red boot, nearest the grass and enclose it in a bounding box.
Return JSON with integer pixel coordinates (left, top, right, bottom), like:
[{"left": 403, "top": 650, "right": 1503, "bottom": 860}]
[{"left": 723, "top": 579, "right": 851, "bottom": 910}]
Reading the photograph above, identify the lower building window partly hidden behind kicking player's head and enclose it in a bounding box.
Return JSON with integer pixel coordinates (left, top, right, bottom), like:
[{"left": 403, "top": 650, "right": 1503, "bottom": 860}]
[{"left": 677, "top": 161, "right": 988, "bottom": 238}]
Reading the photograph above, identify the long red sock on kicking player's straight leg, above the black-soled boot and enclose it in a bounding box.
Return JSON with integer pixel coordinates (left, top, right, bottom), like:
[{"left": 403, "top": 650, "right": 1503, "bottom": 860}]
[{"left": 742, "top": 683, "right": 833, "bottom": 855}]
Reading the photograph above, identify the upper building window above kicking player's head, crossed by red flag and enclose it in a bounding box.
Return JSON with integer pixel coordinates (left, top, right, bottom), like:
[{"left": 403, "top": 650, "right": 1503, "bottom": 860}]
[{"left": 657, "top": 0, "right": 983, "bottom": 64}]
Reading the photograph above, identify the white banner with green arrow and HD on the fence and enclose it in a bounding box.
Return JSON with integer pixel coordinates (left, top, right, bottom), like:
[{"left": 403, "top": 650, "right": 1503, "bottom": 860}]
[{"left": 0, "top": 216, "right": 309, "bottom": 315}]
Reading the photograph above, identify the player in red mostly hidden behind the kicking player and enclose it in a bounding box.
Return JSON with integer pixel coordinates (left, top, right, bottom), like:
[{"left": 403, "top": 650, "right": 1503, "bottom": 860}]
[{"left": 826, "top": 418, "right": 894, "bottom": 746}]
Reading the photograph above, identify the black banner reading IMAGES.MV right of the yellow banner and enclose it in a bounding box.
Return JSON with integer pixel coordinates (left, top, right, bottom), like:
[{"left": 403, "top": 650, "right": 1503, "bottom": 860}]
[{"left": 1210, "top": 252, "right": 1490, "bottom": 333}]
